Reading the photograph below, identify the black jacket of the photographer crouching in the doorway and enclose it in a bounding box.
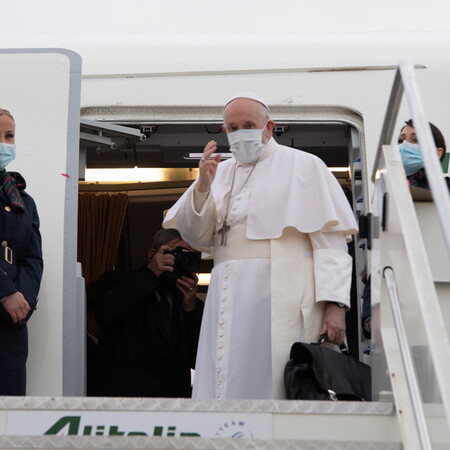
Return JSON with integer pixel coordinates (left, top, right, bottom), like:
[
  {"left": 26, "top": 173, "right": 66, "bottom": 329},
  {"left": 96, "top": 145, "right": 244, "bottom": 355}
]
[{"left": 94, "top": 267, "right": 203, "bottom": 397}]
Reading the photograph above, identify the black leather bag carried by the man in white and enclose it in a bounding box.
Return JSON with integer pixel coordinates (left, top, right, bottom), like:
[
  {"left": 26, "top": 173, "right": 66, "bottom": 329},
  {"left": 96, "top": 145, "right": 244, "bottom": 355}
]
[{"left": 284, "top": 341, "right": 372, "bottom": 401}]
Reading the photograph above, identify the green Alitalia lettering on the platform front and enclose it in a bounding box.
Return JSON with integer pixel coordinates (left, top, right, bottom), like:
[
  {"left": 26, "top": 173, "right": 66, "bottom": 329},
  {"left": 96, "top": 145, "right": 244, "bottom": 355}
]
[{"left": 44, "top": 416, "right": 200, "bottom": 437}]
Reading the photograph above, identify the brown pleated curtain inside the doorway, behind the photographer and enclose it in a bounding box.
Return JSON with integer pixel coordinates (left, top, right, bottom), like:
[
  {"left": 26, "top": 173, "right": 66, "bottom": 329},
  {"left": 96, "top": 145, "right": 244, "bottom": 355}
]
[{"left": 78, "top": 192, "right": 129, "bottom": 285}]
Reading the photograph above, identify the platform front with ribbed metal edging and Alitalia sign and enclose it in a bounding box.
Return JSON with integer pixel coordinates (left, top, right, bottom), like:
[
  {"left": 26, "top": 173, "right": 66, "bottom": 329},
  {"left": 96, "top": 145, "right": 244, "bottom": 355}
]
[{"left": 0, "top": 397, "right": 402, "bottom": 450}]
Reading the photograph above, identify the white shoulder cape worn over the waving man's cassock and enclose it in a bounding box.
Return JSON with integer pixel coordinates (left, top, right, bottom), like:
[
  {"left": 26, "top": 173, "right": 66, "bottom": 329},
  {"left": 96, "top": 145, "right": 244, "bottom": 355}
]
[{"left": 164, "top": 139, "right": 357, "bottom": 253}]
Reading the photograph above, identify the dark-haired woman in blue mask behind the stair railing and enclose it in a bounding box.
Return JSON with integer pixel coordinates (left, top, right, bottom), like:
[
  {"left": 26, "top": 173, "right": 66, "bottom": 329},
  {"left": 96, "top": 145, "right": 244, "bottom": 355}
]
[{"left": 398, "top": 119, "right": 450, "bottom": 190}]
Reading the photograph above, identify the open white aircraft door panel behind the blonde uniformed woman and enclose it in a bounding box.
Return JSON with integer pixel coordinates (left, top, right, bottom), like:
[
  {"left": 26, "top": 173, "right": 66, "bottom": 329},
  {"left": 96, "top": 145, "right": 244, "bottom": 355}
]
[{"left": 0, "top": 49, "right": 84, "bottom": 396}]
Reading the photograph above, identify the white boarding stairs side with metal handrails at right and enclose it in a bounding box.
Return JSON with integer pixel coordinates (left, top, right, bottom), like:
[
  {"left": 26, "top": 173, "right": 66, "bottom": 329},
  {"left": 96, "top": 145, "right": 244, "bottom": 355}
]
[{"left": 369, "top": 61, "right": 450, "bottom": 449}]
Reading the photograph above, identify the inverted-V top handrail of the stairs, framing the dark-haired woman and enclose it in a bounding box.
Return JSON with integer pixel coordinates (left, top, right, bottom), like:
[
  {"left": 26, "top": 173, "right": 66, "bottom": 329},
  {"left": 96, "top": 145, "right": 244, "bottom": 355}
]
[{"left": 372, "top": 60, "right": 450, "bottom": 257}]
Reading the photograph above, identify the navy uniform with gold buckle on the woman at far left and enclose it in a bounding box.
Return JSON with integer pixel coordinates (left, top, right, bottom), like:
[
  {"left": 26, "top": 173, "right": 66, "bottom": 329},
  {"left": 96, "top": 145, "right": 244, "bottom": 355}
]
[{"left": 0, "top": 178, "right": 43, "bottom": 395}]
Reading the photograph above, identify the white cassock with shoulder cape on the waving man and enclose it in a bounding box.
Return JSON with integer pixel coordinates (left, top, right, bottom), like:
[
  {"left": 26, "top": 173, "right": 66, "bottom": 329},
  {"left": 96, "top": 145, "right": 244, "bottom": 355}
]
[{"left": 163, "top": 139, "right": 357, "bottom": 399}]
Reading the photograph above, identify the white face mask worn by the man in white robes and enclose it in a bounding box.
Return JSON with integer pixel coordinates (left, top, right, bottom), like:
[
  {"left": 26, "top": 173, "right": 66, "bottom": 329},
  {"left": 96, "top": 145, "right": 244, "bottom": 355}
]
[{"left": 227, "top": 124, "right": 267, "bottom": 164}]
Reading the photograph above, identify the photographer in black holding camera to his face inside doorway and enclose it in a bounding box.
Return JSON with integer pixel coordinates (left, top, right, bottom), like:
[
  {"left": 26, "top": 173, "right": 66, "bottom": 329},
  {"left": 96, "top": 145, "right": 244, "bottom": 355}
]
[{"left": 94, "top": 229, "right": 203, "bottom": 397}]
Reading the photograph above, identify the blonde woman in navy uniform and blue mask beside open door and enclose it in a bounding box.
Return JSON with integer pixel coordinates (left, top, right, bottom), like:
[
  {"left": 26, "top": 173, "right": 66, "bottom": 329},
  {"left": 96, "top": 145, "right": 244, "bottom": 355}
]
[{"left": 0, "top": 109, "right": 43, "bottom": 395}]
